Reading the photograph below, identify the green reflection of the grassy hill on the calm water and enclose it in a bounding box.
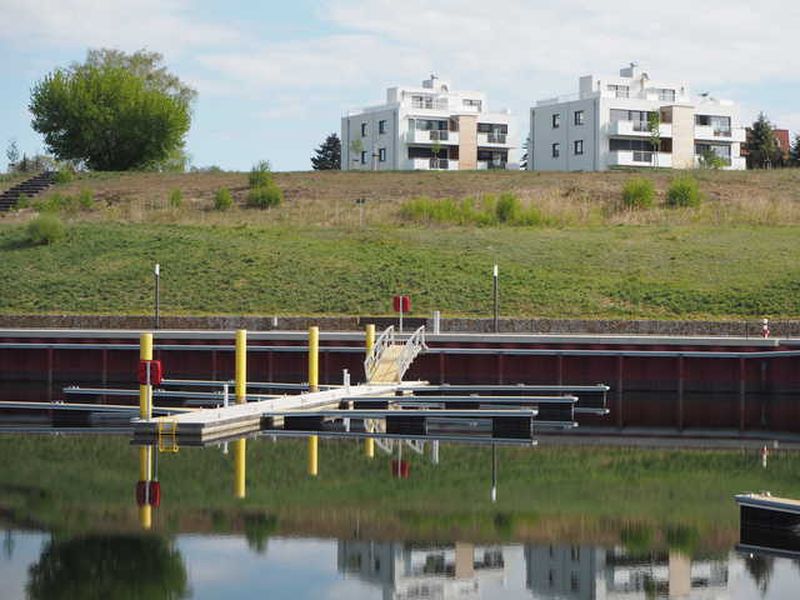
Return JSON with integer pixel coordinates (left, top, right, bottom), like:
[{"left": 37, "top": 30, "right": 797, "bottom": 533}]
[{"left": 0, "top": 437, "right": 800, "bottom": 544}]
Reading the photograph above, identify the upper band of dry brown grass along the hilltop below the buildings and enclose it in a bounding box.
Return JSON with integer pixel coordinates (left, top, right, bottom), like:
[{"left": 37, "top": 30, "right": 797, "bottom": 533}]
[{"left": 12, "top": 169, "right": 800, "bottom": 227}]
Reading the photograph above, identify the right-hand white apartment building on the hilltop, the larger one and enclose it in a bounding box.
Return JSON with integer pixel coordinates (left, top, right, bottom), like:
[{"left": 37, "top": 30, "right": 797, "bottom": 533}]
[{"left": 528, "top": 64, "right": 745, "bottom": 171}]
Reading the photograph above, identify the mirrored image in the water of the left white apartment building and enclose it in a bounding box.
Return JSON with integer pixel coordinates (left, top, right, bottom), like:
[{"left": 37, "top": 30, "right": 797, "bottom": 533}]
[{"left": 337, "top": 540, "right": 505, "bottom": 600}]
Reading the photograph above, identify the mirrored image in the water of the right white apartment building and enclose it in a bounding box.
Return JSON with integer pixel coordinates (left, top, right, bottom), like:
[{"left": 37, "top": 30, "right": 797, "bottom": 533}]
[{"left": 525, "top": 545, "right": 728, "bottom": 600}]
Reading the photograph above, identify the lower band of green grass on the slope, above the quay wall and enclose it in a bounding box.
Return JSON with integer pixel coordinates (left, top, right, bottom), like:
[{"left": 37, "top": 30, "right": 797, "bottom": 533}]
[{"left": 0, "top": 221, "right": 800, "bottom": 319}]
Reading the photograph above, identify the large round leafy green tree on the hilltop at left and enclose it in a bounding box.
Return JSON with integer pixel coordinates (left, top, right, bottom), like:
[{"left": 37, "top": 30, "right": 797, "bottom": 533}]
[{"left": 29, "top": 49, "right": 196, "bottom": 171}]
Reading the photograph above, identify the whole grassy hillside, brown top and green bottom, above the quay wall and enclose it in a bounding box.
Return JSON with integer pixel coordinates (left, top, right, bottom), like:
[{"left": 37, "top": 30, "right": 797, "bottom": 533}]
[{"left": 0, "top": 170, "right": 800, "bottom": 319}]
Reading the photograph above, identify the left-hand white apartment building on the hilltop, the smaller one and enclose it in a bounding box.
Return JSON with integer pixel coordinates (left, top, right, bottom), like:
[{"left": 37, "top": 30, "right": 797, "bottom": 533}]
[{"left": 342, "top": 75, "right": 514, "bottom": 171}]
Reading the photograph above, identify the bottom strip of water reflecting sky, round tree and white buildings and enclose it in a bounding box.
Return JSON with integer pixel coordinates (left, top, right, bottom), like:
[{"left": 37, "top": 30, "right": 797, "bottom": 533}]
[{"left": 0, "top": 532, "right": 800, "bottom": 600}]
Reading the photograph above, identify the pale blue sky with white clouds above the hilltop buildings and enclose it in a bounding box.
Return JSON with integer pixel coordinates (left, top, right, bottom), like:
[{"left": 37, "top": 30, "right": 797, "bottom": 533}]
[{"left": 0, "top": 0, "right": 800, "bottom": 171}]
